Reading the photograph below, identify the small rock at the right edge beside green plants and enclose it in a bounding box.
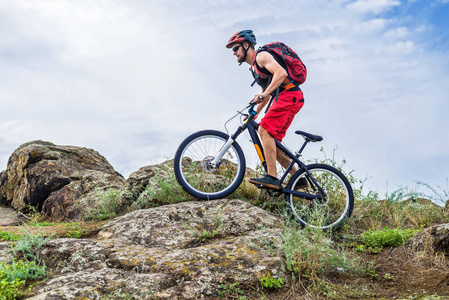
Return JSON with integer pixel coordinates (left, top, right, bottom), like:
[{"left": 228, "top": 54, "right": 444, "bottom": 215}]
[{"left": 405, "top": 224, "right": 449, "bottom": 256}]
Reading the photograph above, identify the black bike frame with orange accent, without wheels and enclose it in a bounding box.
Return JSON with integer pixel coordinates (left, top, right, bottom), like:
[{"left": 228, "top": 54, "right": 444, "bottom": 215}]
[{"left": 231, "top": 109, "right": 322, "bottom": 200}]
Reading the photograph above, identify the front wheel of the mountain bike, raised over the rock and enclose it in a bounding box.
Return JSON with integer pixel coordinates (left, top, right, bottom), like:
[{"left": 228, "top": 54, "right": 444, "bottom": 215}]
[{"left": 174, "top": 130, "right": 246, "bottom": 200}]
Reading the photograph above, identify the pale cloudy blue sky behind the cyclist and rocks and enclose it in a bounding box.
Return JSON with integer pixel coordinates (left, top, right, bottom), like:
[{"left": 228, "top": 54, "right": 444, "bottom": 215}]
[{"left": 0, "top": 0, "right": 449, "bottom": 202}]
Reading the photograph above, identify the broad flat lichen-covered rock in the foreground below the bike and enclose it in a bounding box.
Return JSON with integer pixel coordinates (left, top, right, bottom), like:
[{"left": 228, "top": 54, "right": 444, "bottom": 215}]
[{"left": 30, "top": 200, "right": 284, "bottom": 299}]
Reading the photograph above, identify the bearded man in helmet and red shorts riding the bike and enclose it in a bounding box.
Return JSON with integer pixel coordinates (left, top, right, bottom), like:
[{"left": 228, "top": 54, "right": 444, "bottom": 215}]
[{"left": 226, "top": 30, "right": 304, "bottom": 189}]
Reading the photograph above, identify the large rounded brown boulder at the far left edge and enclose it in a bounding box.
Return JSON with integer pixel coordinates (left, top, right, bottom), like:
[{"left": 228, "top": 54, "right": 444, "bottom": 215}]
[{"left": 0, "top": 141, "right": 125, "bottom": 220}]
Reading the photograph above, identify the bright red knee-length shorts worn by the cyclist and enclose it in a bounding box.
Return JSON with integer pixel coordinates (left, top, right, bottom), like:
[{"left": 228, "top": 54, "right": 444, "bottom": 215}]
[{"left": 259, "top": 90, "right": 304, "bottom": 142}]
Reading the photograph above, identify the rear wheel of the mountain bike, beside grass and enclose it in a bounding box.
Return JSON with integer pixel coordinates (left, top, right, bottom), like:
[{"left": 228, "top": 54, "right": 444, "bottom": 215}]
[{"left": 286, "top": 164, "right": 354, "bottom": 230}]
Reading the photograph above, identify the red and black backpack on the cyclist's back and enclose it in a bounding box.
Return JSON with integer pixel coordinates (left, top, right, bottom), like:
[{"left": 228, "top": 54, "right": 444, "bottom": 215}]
[{"left": 253, "top": 42, "right": 307, "bottom": 85}]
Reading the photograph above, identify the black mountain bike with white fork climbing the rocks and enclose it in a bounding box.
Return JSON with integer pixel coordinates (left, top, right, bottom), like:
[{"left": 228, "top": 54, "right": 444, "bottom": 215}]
[{"left": 174, "top": 103, "right": 354, "bottom": 230}]
